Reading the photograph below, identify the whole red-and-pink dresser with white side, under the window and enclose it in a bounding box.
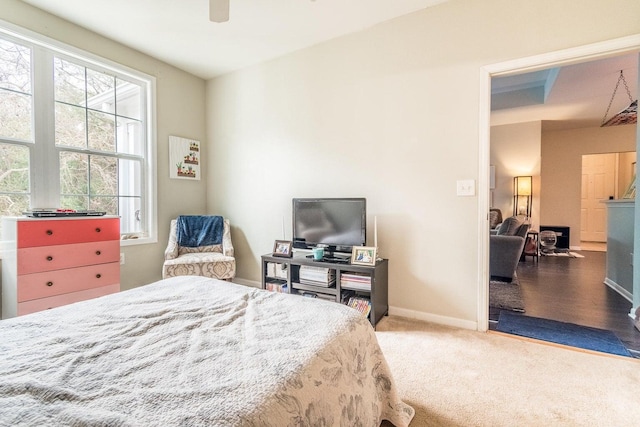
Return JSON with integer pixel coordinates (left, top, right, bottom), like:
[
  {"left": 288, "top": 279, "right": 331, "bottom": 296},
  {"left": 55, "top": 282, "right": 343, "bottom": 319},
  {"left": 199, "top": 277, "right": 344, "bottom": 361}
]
[{"left": 2, "top": 216, "right": 120, "bottom": 319}]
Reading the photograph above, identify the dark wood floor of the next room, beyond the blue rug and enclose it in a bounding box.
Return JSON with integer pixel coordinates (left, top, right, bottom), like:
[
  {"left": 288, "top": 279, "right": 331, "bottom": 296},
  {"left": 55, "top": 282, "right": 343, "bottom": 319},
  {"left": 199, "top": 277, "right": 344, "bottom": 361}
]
[{"left": 489, "top": 251, "right": 640, "bottom": 357}]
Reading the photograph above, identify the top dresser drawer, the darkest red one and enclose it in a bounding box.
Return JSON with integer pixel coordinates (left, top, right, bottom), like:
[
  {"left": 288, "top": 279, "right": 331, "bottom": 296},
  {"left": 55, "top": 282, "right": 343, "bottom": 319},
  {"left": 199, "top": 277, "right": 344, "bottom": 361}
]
[{"left": 17, "top": 218, "right": 120, "bottom": 248}]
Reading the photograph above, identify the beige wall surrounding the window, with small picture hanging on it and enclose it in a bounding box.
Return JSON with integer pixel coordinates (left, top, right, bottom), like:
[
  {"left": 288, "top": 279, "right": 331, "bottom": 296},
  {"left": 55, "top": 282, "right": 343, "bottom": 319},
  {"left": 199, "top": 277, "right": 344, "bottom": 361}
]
[{"left": 0, "top": 0, "right": 209, "bottom": 289}]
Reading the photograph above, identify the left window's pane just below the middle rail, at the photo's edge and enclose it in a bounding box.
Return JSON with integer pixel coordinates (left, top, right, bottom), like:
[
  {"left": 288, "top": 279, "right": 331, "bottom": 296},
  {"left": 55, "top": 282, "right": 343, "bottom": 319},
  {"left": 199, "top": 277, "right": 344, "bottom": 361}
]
[{"left": 0, "top": 144, "right": 29, "bottom": 191}]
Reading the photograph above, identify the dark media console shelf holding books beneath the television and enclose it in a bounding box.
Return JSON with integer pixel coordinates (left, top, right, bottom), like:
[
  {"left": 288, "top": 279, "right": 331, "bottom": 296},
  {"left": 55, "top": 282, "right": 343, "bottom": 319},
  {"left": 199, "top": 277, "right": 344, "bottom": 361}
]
[{"left": 262, "top": 254, "right": 389, "bottom": 327}]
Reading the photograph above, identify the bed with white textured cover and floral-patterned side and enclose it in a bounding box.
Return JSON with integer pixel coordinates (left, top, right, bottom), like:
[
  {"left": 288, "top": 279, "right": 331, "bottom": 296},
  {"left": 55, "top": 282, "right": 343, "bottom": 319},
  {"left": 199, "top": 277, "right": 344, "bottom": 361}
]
[{"left": 0, "top": 276, "right": 414, "bottom": 427}]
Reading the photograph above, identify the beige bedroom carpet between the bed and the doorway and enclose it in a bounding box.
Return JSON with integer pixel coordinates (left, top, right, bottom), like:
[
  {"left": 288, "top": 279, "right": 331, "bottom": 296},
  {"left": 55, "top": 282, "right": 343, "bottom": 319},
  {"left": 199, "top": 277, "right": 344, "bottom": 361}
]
[{"left": 376, "top": 316, "right": 640, "bottom": 427}]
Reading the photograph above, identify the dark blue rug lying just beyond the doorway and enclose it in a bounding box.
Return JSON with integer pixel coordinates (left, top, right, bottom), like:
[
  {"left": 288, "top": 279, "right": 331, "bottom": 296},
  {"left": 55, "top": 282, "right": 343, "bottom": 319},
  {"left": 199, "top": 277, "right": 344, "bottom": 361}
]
[{"left": 496, "top": 311, "right": 633, "bottom": 357}]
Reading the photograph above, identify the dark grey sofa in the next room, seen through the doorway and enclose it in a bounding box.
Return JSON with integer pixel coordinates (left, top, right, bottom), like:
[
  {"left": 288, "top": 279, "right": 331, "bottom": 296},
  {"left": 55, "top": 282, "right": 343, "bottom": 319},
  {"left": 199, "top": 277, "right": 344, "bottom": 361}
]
[{"left": 489, "top": 216, "right": 529, "bottom": 282}]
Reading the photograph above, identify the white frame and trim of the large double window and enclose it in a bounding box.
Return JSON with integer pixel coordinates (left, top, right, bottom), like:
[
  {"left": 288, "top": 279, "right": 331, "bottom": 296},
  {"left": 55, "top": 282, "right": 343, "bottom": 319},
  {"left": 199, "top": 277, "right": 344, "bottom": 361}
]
[{"left": 0, "top": 20, "right": 158, "bottom": 246}]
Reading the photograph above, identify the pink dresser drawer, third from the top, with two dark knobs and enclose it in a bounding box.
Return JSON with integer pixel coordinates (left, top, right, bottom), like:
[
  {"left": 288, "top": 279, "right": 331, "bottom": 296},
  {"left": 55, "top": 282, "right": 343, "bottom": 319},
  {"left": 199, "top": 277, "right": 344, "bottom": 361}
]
[{"left": 18, "top": 262, "right": 120, "bottom": 303}]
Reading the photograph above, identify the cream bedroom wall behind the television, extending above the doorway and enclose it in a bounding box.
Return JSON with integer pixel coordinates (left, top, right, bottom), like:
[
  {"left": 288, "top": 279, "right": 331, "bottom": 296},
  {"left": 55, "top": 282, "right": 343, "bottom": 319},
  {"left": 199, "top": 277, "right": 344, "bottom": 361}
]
[{"left": 207, "top": 0, "right": 640, "bottom": 327}]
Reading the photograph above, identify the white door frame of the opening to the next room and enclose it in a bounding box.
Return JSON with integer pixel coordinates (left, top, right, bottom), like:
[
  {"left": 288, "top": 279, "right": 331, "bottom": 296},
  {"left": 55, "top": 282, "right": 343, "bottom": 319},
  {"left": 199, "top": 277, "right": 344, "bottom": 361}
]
[{"left": 477, "top": 34, "right": 640, "bottom": 331}]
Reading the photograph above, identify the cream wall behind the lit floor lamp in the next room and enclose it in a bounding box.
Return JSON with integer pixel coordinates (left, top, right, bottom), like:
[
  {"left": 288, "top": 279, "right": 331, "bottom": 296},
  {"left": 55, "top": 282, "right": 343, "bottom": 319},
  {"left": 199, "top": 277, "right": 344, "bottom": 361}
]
[{"left": 489, "top": 121, "right": 542, "bottom": 229}]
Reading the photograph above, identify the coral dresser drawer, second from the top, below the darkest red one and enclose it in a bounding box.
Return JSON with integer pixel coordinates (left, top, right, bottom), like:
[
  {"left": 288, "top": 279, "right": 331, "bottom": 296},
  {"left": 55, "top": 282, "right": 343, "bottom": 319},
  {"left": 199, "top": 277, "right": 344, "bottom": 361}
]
[{"left": 18, "top": 240, "right": 120, "bottom": 275}]
